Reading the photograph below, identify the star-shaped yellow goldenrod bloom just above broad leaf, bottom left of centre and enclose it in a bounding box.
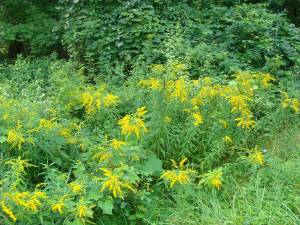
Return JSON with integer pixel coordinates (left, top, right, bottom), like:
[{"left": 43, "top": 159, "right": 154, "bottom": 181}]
[{"left": 100, "top": 168, "right": 134, "bottom": 199}]
